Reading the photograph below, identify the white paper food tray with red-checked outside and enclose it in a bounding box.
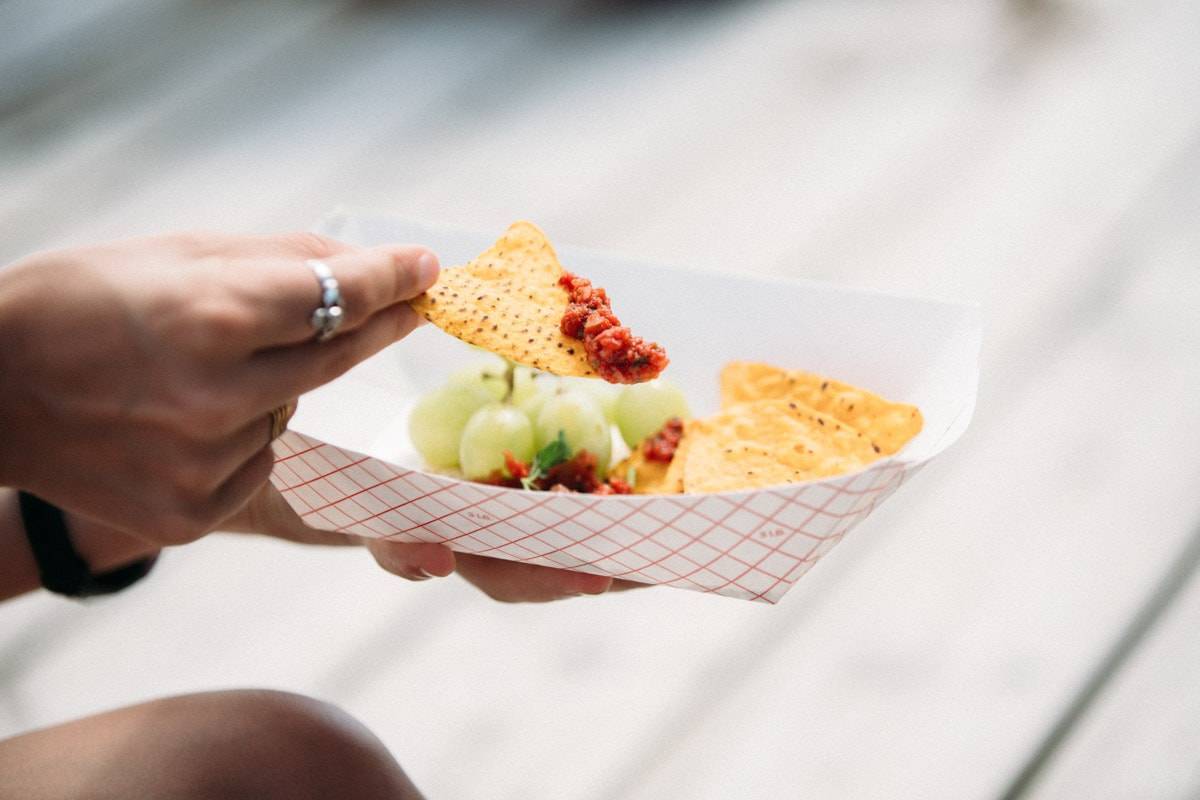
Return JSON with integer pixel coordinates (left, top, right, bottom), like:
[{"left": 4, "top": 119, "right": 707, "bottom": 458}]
[{"left": 271, "top": 213, "right": 980, "bottom": 603}]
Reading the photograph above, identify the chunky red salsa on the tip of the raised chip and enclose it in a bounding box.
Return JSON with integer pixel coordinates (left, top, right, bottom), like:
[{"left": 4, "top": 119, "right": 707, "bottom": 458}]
[{"left": 558, "top": 272, "right": 668, "bottom": 384}]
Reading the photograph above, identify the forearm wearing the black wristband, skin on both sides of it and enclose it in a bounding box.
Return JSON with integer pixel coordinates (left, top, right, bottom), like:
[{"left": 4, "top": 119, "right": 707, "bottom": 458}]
[{"left": 0, "top": 488, "right": 158, "bottom": 600}]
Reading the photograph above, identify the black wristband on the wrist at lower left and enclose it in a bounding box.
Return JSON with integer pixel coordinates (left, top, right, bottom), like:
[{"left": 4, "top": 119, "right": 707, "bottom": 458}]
[{"left": 17, "top": 492, "right": 156, "bottom": 597}]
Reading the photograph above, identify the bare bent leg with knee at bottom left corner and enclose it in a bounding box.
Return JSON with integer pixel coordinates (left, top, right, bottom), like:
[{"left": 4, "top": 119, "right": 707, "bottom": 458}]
[{"left": 0, "top": 691, "right": 421, "bottom": 800}]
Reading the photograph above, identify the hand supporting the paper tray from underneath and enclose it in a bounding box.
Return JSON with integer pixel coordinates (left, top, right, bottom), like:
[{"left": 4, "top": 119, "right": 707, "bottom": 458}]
[{"left": 222, "top": 485, "right": 641, "bottom": 602}]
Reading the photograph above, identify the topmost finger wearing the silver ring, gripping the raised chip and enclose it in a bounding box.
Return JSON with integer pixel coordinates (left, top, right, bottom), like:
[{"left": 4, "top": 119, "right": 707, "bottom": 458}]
[{"left": 236, "top": 245, "right": 438, "bottom": 348}]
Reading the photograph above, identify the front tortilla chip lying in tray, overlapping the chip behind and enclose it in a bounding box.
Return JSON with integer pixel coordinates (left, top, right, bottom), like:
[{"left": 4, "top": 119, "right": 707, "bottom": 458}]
[{"left": 676, "top": 399, "right": 880, "bottom": 493}]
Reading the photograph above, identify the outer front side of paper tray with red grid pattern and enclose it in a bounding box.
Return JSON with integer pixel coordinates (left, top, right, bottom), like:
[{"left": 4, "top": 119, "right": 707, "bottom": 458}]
[{"left": 271, "top": 431, "right": 919, "bottom": 602}]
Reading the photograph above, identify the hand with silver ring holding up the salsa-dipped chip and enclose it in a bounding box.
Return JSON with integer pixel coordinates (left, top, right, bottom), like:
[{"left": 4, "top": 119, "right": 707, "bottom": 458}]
[{"left": 0, "top": 234, "right": 438, "bottom": 545}]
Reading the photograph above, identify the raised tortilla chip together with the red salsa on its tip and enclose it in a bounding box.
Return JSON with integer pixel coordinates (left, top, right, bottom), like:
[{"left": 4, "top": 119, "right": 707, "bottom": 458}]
[{"left": 410, "top": 222, "right": 667, "bottom": 384}]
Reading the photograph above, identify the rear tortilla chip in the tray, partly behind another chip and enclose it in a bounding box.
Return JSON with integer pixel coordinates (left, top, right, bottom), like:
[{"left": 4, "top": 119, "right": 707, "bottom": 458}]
[{"left": 721, "top": 361, "right": 924, "bottom": 456}]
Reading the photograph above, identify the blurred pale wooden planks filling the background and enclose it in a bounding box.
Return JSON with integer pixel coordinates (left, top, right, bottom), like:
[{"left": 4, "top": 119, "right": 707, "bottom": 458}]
[{"left": 0, "top": 0, "right": 1200, "bottom": 800}]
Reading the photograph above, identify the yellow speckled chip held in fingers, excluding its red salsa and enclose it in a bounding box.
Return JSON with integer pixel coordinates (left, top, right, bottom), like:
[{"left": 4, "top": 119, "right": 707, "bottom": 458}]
[{"left": 409, "top": 222, "right": 595, "bottom": 378}]
